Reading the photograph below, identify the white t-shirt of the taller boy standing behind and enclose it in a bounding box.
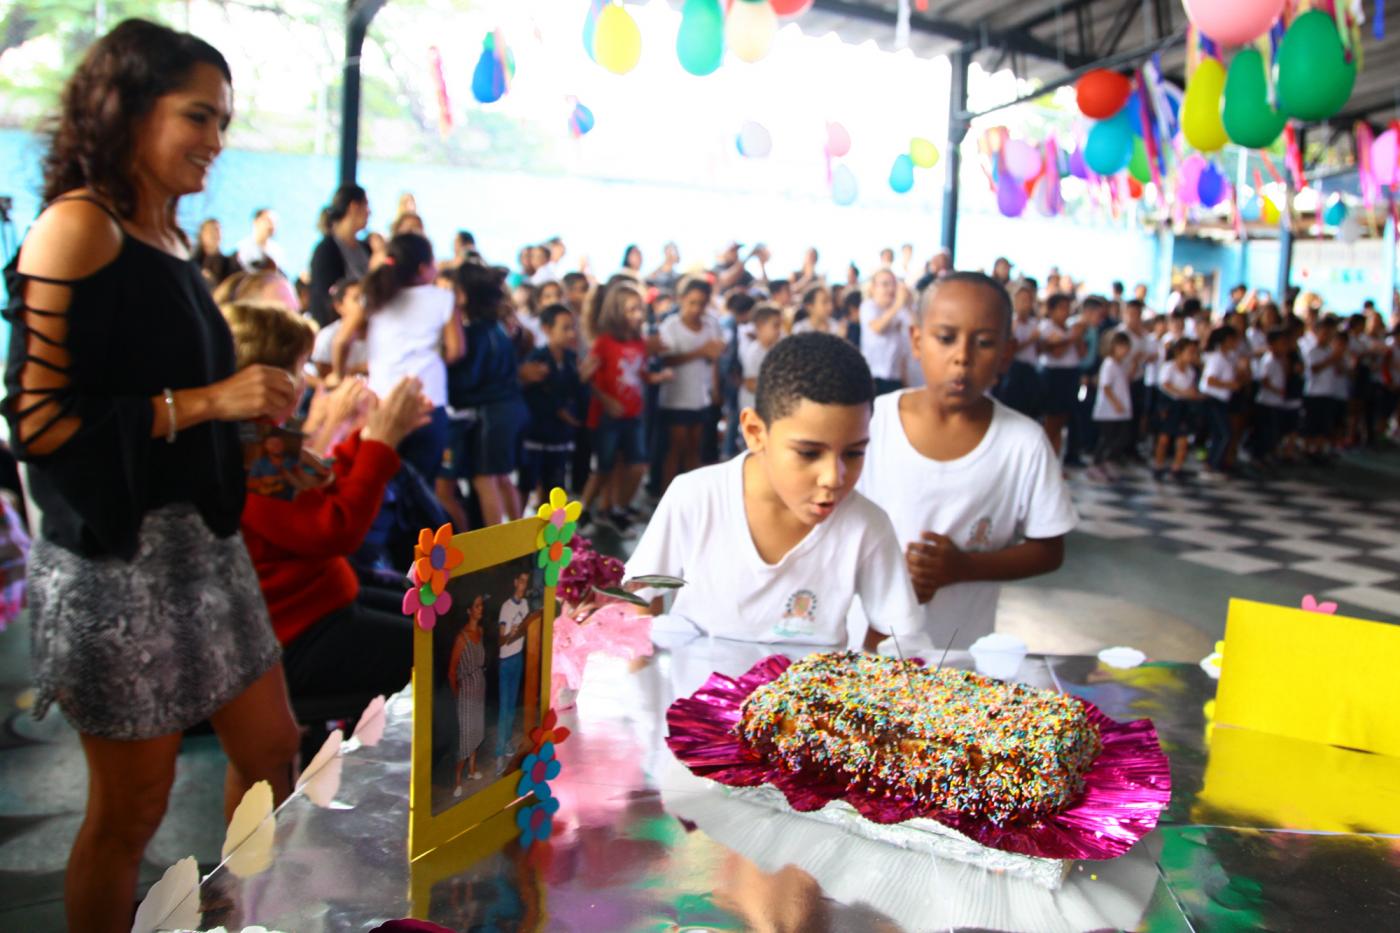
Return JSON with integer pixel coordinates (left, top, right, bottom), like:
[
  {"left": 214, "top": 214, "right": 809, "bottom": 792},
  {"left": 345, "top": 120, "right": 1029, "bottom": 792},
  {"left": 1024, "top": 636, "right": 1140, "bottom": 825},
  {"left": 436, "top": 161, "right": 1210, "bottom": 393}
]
[{"left": 855, "top": 392, "right": 1079, "bottom": 649}]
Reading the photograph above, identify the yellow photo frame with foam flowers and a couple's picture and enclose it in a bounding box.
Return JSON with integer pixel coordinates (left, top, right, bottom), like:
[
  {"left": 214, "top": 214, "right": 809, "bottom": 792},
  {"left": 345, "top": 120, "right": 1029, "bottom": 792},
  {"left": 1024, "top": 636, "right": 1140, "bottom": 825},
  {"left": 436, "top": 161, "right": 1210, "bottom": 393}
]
[{"left": 405, "top": 509, "right": 557, "bottom": 860}]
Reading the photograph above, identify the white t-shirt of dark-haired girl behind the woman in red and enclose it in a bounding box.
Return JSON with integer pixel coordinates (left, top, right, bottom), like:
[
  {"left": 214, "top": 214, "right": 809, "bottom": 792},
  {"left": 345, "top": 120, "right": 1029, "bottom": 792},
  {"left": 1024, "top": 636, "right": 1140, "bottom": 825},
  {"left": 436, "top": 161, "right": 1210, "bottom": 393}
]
[{"left": 365, "top": 284, "right": 452, "bottom": 408}]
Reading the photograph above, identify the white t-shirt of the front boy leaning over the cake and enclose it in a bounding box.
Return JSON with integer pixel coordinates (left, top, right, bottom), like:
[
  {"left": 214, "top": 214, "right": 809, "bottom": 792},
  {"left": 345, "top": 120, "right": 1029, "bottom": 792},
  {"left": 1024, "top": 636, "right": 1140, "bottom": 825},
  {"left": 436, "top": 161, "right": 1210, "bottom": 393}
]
[{"left": 627, "top": 454, "right": 918, "bottom": 646}]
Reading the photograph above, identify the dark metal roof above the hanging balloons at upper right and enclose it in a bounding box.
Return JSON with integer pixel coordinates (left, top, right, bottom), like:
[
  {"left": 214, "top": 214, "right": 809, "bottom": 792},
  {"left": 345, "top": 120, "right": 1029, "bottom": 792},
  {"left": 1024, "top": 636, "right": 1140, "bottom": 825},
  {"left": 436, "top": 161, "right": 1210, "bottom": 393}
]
[{"left": 797, "top": 0, "right": 1400, "bottom": 127}]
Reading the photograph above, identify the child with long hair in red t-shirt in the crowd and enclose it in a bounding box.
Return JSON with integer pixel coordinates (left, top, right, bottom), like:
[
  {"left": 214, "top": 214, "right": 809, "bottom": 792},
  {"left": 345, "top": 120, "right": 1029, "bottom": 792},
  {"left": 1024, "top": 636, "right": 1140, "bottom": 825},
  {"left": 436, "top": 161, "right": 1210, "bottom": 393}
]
[{"left": 582, "top": 284, "right": 672, "bottom": 532}]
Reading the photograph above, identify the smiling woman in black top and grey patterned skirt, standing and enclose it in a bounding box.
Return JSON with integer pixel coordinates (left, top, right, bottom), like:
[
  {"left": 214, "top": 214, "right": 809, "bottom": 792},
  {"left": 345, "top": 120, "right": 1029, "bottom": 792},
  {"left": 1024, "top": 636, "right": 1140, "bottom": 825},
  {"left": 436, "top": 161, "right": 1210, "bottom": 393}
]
[{"left": 6, "top": 20, "right": 298, "bottom": 930}]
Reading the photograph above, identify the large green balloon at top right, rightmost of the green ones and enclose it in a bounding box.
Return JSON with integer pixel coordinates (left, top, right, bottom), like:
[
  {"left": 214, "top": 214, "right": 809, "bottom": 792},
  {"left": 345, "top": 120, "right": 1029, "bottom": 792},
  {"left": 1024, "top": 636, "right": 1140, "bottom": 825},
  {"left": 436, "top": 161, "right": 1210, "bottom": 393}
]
[{"left": 1274, "top": 10, "right": 1357, "bottom": 120}]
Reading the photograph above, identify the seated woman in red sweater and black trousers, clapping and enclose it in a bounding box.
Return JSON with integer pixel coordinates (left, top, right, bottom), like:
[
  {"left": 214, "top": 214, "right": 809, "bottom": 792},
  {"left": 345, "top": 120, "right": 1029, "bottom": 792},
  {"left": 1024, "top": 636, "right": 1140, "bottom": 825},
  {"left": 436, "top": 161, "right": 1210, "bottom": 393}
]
[{"left": 223, "top": 303, "right": 431, "bottom": 719}]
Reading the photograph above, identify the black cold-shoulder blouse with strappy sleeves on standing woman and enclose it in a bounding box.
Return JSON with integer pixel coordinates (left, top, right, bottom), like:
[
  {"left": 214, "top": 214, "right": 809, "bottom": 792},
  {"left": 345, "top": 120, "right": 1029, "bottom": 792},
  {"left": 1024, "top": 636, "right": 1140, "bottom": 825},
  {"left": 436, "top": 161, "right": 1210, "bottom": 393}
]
[{"left": 4, "top": 198, "right": 245, "bottom": 560}]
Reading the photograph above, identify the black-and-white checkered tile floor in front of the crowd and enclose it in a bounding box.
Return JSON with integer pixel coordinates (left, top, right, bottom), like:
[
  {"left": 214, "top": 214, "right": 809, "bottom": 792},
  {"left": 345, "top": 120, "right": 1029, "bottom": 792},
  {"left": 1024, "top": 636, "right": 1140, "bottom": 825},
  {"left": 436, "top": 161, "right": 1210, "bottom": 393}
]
[{"left": 1070, "top": 467, "right": 1400, "bottom": 616}]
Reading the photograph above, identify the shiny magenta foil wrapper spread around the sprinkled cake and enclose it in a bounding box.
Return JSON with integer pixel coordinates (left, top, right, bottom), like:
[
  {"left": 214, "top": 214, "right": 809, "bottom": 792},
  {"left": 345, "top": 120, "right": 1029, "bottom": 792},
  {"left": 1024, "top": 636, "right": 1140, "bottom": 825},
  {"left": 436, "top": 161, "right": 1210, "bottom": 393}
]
[{"left": 666, "top": 654, "right": 1172, "bottom": 859}]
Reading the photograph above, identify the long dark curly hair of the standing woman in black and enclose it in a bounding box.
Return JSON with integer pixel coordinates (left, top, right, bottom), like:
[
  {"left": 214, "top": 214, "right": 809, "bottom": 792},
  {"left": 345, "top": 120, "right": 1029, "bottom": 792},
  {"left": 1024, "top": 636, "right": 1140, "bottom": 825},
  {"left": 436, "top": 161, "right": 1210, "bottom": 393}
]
[{"left": 43, "top": 20, "right": 232, "bottom": 217}]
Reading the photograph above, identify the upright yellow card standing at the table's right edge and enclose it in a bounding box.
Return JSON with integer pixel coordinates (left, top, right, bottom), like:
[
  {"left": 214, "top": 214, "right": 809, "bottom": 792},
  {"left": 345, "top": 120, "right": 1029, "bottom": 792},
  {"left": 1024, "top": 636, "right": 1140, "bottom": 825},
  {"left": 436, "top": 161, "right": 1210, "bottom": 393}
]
[{"left": 1215, "top": 600, "right": 1400, "bottom": 755}]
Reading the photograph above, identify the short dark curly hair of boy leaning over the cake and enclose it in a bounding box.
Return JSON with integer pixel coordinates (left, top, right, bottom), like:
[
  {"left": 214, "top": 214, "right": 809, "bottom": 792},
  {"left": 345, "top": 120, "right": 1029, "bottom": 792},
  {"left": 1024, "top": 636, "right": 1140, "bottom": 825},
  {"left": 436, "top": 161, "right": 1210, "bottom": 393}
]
[{"left": 753, "top": 332, "right": 875, "bottom": 426}]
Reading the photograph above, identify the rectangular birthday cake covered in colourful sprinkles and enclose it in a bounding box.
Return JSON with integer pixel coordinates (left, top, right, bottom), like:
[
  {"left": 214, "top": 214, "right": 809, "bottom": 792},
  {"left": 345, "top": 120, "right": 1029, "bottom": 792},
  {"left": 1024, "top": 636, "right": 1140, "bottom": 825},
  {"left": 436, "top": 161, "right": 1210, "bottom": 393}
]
[{"left": 736, "top": 651, "right": 1102, "bottom": 824}]
